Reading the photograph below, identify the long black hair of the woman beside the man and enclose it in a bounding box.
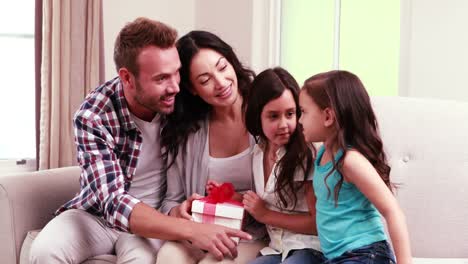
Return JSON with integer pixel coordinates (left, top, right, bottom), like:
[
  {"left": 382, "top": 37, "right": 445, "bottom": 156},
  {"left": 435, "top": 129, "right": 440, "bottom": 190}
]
[{"left": 161, "top": 30, "right": 255, "bottom": 166}]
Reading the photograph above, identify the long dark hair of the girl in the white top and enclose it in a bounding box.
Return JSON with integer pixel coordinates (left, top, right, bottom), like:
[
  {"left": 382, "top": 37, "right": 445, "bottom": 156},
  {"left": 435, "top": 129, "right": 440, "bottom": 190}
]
[{"left": 244, "top": 67, "right": 315, "bottom": 208}]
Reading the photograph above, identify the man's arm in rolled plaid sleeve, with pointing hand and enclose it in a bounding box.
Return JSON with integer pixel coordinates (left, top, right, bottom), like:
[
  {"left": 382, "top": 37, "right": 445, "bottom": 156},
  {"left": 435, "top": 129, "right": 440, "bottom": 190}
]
[{"left": 74, "top": 110, "right": 251, "bottom": 259}]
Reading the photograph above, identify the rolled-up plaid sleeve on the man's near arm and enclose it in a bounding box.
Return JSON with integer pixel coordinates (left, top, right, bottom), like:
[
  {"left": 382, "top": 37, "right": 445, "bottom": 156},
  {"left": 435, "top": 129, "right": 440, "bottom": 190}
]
[{"left": 74, "top": 110, "right": 140, "bottom": 232}]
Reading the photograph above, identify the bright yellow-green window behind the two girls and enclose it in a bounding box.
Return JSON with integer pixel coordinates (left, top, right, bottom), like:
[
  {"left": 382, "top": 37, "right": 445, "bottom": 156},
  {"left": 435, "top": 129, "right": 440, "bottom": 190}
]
[{"left": 281, "top": 0, "right": 400, "bottom": 95}]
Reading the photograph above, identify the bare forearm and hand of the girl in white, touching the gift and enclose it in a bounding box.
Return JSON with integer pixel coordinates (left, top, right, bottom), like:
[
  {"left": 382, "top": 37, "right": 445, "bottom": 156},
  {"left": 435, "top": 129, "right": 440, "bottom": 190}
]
[{"left": 242, "top": 181, "right": 317, "bottom": 235}]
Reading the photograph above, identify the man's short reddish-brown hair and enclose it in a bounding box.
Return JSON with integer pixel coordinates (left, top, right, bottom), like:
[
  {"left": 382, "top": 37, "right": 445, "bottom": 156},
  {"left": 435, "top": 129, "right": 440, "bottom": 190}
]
[{"left": 114, "top": 17, "right": 177, "bottom": 76}]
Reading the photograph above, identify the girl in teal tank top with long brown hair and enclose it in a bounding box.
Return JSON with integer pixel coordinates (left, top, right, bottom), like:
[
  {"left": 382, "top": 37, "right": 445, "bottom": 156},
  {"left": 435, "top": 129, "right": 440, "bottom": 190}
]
[{"left": 299, "top": 71, "right": 411, "bottom": 264}]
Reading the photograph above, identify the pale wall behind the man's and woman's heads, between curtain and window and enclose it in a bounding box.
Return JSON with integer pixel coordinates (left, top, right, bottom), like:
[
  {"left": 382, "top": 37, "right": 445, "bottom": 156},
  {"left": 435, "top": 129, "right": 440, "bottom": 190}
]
[{"left": 103, "top": 0, "right": 270, "bottom": 80}]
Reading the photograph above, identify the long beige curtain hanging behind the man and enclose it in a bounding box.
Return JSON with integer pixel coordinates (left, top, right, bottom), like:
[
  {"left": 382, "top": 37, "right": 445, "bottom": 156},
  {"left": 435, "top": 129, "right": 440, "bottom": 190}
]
[{"left": 39, "top": 0, "right": 104, "bottom": 170}]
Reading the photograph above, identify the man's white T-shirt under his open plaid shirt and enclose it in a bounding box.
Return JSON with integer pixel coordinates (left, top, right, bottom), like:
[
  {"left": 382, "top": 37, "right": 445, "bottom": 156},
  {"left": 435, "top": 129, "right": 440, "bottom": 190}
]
[{"left": 128, "top": 113, "right": 166, "bottom": 208}]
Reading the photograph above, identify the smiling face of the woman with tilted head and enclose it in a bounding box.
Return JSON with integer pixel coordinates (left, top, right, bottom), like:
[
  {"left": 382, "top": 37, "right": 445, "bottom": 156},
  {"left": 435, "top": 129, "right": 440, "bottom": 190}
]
[{"left": 190, "top": 49, "right": 239, "bottom": 107}]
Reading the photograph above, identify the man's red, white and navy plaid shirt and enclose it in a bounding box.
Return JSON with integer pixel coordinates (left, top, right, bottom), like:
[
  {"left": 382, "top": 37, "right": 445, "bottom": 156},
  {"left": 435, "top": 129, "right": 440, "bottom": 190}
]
[{"left": 56, "top": 77, "right": 146, "bottom": 231}]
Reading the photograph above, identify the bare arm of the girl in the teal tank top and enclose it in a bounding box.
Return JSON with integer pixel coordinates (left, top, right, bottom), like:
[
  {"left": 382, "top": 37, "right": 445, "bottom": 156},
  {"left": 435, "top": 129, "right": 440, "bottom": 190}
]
[{"left": 342, "top": 150, "right": 412, "bottom": 264}]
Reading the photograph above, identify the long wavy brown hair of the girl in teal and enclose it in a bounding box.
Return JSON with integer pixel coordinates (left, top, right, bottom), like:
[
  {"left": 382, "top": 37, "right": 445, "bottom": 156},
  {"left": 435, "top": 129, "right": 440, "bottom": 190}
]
[{"left": 303, "top": 71, "right": 393, "bottom": 201}]
